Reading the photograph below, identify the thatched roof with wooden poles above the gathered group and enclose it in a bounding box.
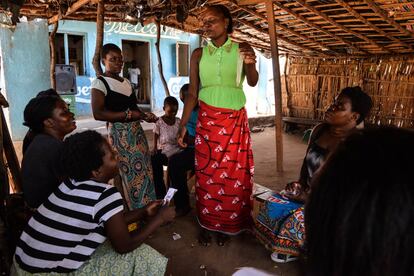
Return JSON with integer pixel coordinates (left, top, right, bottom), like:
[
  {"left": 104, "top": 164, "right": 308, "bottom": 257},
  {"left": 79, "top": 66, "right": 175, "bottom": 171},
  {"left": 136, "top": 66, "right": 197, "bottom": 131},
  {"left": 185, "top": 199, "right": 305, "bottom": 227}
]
[{"left": 1, "top": 0, "right": 414, "bottom": 56}]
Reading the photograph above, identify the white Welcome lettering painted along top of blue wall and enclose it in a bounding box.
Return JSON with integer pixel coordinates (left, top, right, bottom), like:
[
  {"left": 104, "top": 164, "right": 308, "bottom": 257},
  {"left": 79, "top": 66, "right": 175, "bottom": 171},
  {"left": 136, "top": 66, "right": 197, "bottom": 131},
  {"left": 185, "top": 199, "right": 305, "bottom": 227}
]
[{"left": 104, "top": 22, "right": 184, "bottom": 38}]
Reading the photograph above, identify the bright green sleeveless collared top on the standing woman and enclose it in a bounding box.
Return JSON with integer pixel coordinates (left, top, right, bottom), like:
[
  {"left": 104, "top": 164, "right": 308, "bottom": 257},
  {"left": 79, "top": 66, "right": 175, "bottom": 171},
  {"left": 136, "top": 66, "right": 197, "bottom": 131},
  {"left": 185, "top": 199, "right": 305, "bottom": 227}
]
[{"left": 198, "top": 38, "right": 246, "bottom": 110}]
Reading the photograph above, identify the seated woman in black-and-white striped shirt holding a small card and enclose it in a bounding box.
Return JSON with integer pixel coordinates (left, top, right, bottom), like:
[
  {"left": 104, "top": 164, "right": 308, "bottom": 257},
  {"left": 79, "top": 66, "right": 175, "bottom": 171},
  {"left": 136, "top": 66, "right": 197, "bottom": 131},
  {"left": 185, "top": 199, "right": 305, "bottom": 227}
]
[{"left": 12, "top": 131, "right": 175, "bottom": 275}]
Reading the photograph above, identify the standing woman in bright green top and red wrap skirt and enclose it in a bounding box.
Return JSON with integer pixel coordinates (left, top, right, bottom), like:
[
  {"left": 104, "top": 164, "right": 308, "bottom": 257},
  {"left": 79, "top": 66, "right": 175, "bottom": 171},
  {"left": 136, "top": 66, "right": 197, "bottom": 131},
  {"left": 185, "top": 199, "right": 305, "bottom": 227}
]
[{"left": 178, "top": 5, "right": 259, "bottom": 246}]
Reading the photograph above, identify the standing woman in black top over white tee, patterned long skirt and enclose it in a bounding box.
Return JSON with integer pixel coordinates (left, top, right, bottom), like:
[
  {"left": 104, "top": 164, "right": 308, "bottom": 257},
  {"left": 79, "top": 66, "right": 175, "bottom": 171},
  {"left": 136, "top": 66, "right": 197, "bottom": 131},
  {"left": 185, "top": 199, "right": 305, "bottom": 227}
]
[{"left": 92, "top": 44, "right": 157, "bottom": 209}]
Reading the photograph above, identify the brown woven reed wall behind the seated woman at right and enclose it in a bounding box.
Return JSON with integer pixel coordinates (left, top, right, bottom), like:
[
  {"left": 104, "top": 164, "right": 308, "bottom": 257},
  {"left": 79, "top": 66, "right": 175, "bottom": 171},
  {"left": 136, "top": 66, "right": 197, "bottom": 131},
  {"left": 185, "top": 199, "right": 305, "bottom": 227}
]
[{"left": 282, "top": 56, "right": 414, "bottom": 128}]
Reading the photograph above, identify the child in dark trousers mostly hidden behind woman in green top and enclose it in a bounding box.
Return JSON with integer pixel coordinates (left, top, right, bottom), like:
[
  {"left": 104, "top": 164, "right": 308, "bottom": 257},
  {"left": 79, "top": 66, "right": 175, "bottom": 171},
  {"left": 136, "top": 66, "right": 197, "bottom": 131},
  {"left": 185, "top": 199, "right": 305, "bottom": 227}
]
[{"left": 168, "top": 84, "right": 198, "bottom": 216}]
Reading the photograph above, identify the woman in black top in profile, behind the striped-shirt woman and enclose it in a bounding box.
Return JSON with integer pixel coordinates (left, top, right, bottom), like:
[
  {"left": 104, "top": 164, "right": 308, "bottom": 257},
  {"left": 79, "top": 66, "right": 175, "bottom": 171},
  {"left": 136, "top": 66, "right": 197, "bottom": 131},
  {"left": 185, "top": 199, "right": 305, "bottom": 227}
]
[{"left": 22, "top": 90, "right": 76, "bottom": 208}]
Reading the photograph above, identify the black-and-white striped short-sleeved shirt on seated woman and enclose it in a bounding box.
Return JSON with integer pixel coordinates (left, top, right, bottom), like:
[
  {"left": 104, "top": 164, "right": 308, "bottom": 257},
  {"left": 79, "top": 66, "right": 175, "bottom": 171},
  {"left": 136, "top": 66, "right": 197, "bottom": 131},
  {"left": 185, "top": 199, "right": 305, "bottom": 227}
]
[{"left": 15, "top": 180, "right": 123, "bottom": 273}]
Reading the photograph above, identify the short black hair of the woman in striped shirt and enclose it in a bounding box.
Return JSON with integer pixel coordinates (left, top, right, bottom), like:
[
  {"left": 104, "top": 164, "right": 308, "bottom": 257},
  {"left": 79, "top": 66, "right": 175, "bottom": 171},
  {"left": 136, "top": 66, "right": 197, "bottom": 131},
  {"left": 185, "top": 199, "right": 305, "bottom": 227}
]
[{"left": 61, "top": 130, "right": 106, "bottom": 181}]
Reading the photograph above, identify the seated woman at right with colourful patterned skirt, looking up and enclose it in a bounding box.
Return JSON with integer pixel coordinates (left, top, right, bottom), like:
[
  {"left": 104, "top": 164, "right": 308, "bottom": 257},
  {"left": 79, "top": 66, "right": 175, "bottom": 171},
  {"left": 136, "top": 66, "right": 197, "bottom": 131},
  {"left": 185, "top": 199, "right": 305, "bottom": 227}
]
[{"left": 255, "top": 87, "right": 372, "bottom": 262}]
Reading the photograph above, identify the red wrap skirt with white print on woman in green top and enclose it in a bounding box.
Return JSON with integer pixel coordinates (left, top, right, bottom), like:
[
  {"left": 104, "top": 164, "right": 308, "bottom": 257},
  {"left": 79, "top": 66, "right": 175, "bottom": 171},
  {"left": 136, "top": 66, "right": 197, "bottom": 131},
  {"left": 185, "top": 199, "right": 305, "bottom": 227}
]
[{"left": 195, "top": 102, "right": 254, "bottom": 234}]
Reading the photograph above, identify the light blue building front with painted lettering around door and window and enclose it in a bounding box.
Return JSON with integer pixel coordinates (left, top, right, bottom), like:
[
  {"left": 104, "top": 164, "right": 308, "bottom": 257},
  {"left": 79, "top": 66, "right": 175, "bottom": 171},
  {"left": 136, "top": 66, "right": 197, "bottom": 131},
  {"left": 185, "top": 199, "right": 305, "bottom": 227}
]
[{"left": 58, "top": 20, "right": 199, "bottom": 116}]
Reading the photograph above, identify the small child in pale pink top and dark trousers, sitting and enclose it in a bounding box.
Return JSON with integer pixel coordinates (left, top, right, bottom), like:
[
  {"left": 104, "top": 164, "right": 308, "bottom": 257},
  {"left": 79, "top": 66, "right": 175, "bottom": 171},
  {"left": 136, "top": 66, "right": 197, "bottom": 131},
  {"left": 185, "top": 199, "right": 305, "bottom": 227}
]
[{"left": 151, "top": 96, "right": 181, "bottom": 199}]
